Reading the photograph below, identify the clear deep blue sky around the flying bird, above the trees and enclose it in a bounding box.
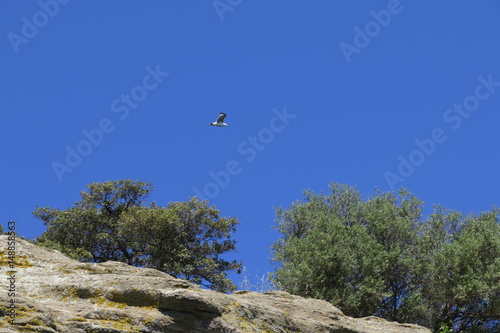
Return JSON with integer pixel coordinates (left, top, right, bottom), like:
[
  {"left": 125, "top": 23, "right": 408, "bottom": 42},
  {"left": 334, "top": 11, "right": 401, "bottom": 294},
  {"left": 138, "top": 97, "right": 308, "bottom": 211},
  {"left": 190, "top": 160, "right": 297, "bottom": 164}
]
[{"left": 0, "top": 0, "right": 500, "bottom": 283}]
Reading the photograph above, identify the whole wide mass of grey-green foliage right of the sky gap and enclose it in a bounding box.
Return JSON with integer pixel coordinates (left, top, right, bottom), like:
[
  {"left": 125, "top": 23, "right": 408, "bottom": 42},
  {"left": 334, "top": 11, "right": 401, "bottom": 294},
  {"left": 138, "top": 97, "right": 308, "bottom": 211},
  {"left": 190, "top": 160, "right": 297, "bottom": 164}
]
[{"left": 273, "top": 184, "right": 500, "bottom": 332}]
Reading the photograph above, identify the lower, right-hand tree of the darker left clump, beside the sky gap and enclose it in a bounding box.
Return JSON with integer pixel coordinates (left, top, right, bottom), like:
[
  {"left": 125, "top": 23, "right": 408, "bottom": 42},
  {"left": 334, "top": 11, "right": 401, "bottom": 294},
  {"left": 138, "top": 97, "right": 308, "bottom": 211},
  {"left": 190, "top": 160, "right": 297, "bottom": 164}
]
[{"left": 122, "top": 198, "right": 241, "bottom": 291}]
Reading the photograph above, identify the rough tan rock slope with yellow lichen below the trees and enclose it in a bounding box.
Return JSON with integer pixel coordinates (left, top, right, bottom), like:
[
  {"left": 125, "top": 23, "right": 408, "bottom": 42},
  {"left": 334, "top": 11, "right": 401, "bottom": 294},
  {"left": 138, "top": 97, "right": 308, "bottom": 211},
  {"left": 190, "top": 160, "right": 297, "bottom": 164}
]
[{"left": 0, "top": 235, "right": 430, "bottom": 333}]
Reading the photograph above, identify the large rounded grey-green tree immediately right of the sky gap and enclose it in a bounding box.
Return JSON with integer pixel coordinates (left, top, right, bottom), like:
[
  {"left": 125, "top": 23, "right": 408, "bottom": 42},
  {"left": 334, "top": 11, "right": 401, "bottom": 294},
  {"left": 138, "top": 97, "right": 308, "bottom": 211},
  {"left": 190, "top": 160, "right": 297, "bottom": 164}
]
[{"left": 273, "top": 184, "right": 386, "bottom": 316}]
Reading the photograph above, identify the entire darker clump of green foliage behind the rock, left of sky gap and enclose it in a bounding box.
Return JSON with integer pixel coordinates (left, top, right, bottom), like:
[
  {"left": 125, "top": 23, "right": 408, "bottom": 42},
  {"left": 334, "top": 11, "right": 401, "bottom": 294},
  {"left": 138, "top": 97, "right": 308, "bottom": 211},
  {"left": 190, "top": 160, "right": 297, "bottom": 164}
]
[{"left": 33, "top": 180, "right": 241, "bottom": 292}]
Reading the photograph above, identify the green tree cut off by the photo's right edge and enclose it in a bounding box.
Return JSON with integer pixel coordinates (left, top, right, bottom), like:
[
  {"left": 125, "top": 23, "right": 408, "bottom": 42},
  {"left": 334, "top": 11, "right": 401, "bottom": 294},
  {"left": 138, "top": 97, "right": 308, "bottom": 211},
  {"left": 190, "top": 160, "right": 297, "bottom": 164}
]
[{"left": 421, "top": 206, "right": 500, "bottom": 332}]
